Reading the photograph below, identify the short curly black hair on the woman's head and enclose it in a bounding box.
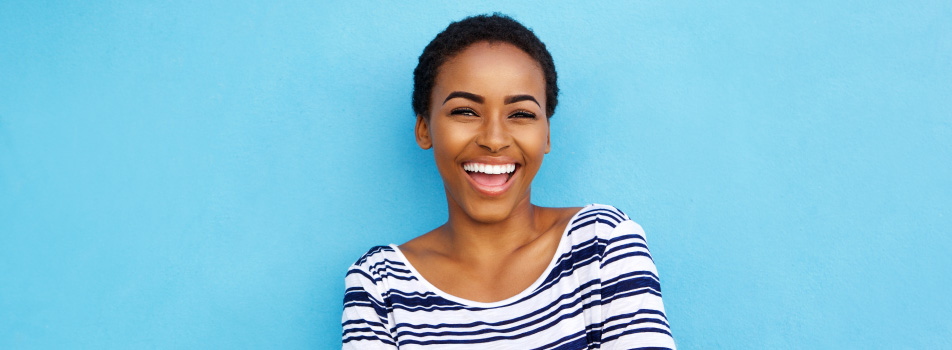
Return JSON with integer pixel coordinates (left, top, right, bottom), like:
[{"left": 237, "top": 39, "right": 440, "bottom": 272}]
[{"left": 413, "top": 13, "right": 559, "bottom": 119}]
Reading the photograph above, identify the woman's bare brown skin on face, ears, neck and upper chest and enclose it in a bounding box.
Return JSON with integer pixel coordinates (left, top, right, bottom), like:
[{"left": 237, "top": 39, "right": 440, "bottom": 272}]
[{"left": 400, "top": 42, "right": 579, "bottom": 302}]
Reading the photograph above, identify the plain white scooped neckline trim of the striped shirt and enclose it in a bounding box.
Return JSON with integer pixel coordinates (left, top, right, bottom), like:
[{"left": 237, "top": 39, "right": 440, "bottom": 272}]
[{"left": 390, "top": 204, "right": 594, "bottom": 308}]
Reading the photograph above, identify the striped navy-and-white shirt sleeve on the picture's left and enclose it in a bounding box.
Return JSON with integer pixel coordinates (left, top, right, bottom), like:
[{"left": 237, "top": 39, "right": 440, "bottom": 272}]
[{"left": 341, "top": 265, "right": 397, "bottom": 350}]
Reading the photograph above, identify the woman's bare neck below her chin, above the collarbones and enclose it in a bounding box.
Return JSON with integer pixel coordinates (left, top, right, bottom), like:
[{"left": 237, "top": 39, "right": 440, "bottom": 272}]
[{"left": 442, "top": 194, "right": 543, "bottom": 261}]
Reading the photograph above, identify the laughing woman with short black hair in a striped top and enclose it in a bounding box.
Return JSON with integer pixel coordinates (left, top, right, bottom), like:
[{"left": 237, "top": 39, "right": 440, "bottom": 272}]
[{"left": 343, "top": 15, "right": 674, "bottom": 349}]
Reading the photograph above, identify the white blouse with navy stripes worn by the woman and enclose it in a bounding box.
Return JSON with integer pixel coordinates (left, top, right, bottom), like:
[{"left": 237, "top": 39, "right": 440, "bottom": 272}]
[{"left": 342, "top": 204, "right": 675, "bottom": 349}]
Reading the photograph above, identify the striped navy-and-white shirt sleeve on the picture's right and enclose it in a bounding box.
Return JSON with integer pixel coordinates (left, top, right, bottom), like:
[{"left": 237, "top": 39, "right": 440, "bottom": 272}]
[{"left": 600, "top": 217, "right": 676, "bottom": 349}]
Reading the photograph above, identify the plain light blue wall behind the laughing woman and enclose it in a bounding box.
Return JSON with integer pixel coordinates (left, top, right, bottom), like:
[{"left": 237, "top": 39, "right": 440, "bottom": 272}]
[{"left": 0, "top": 0, "right": 952, "bottom": 349}]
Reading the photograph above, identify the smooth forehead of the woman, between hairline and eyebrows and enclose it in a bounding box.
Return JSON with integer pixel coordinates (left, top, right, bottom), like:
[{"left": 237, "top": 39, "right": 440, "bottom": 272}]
[{"left": 432, "top": 42, "right": 545, "bottom": 102}]
